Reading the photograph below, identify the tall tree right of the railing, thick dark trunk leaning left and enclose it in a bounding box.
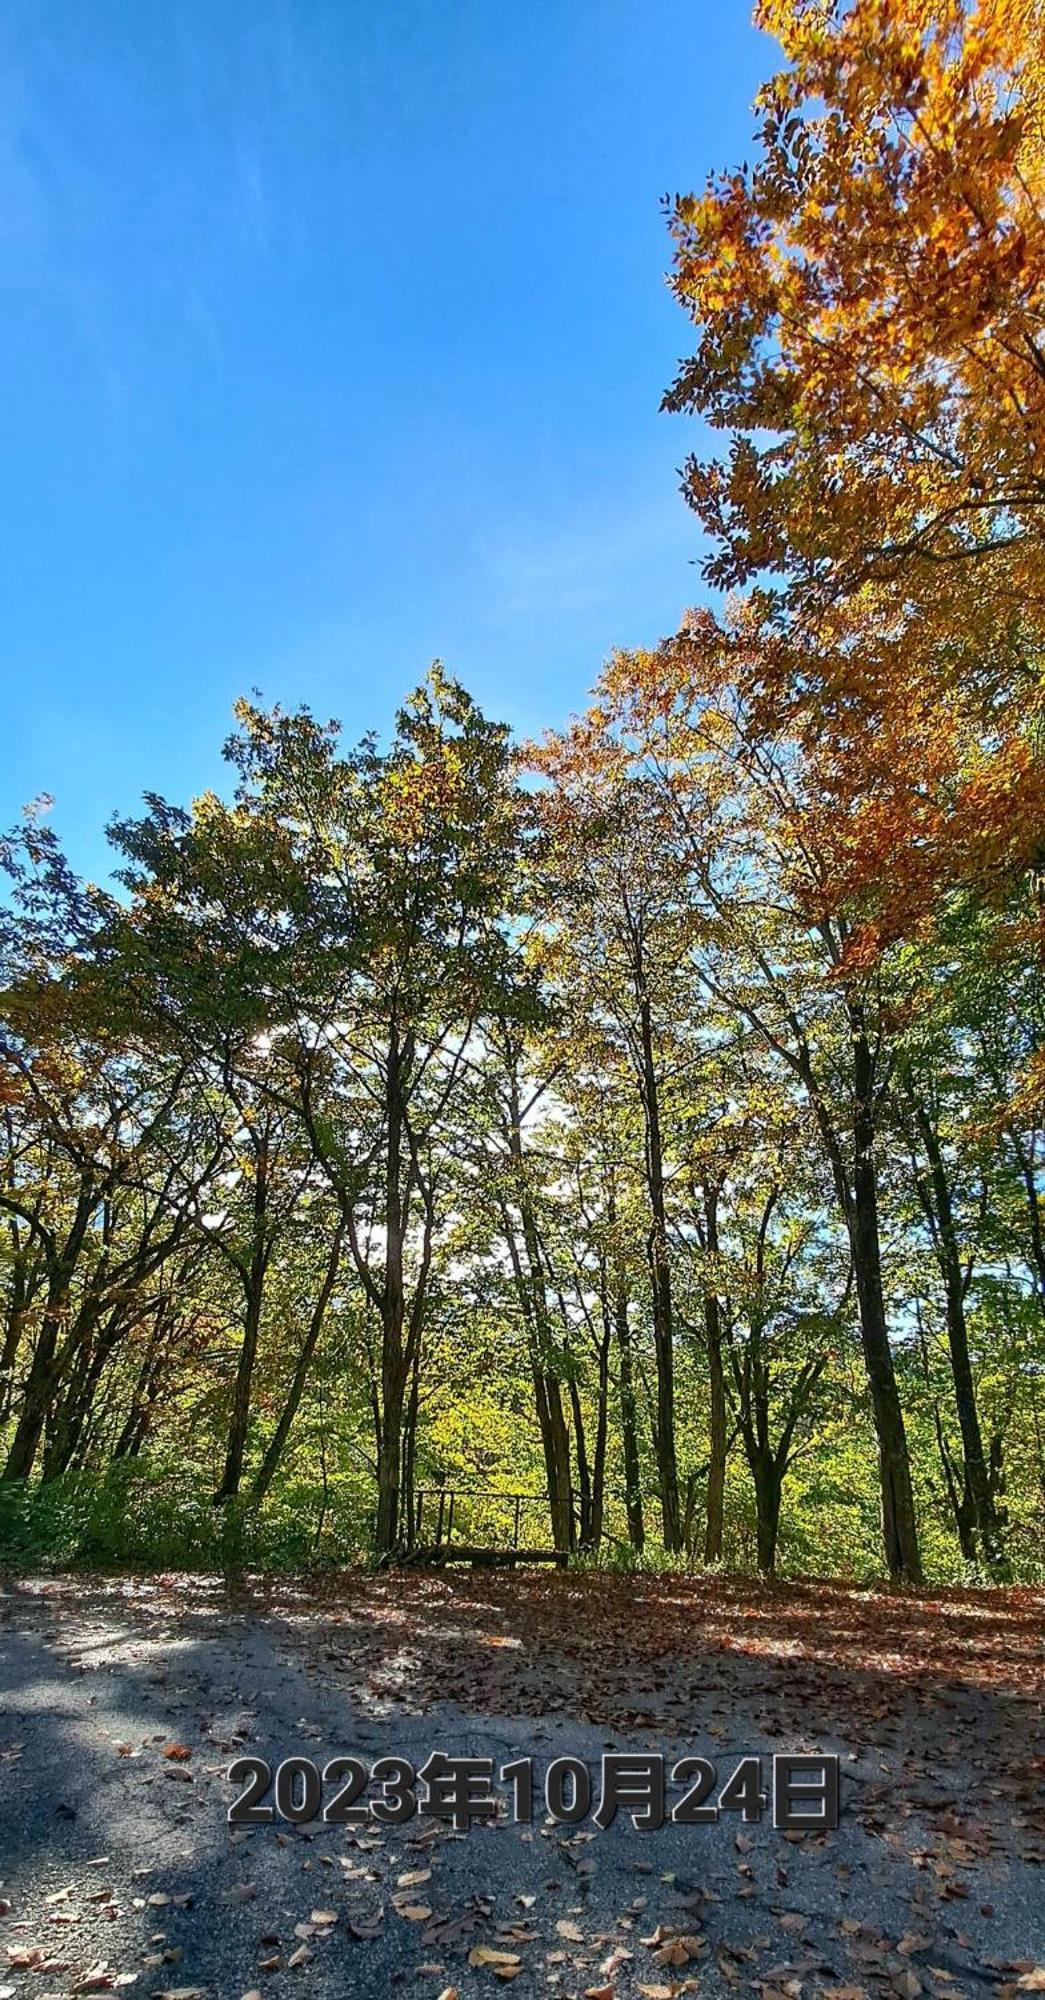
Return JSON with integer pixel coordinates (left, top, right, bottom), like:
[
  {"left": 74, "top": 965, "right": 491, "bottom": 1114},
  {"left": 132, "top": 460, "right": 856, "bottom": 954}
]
[{"left": 580, "top": 636, "right": 921, "bottom": 1582}]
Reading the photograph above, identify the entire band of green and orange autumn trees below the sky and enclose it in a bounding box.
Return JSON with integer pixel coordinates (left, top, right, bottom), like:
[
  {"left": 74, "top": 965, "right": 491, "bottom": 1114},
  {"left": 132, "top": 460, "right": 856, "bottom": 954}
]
[{"left": 0, "top": 0, "right": 1045, "bottom": 1584}]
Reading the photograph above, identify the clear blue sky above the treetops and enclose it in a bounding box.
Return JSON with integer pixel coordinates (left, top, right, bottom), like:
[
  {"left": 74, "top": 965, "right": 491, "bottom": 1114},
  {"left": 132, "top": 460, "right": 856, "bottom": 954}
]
[{"left": 0, "top": 0, "right": 773, "bottom": 874}]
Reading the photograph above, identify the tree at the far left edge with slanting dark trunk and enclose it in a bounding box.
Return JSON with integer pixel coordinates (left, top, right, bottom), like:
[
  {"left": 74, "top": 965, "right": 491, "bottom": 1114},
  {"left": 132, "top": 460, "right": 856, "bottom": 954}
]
[{"left": 0, "top": 814, "right": 194, "bottom": 1480}]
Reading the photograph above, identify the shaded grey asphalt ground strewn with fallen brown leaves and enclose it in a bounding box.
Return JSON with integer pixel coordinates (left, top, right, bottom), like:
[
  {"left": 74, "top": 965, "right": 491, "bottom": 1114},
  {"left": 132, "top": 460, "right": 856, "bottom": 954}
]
[{"left": 0, "top": 1572, "right": 1045, "bottom": 2000}]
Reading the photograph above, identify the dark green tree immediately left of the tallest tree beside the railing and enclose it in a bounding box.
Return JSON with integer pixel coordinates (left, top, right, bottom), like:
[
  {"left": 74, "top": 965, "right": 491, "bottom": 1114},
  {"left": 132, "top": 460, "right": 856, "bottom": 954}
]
[{"left": 96, "top": 794, "right": 338, "bottom": 1504}]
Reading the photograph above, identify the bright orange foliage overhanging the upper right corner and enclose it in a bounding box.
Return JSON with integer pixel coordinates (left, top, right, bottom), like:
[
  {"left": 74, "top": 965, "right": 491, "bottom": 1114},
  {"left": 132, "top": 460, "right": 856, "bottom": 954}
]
[{"left": 665, "top": 0, "right": 1045, "bottom": 934}]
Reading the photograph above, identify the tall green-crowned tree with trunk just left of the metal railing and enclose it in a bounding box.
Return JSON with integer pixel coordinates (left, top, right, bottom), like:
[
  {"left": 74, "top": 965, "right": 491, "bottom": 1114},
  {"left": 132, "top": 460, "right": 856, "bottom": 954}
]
[{"left": 206, "top": 666, "right": 518, "bottom": 1552}]
